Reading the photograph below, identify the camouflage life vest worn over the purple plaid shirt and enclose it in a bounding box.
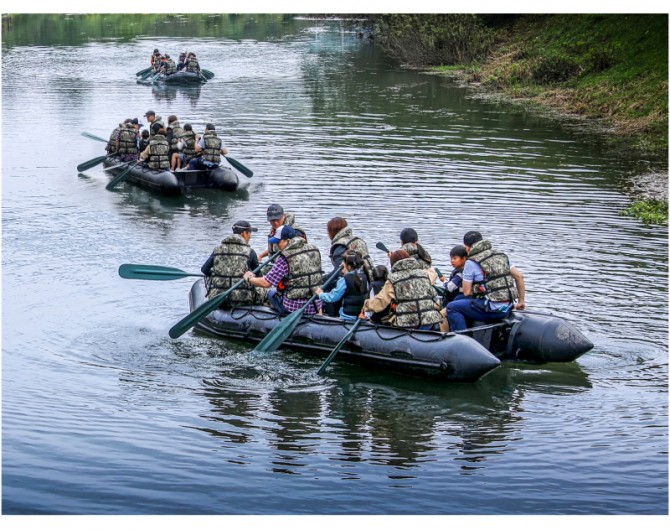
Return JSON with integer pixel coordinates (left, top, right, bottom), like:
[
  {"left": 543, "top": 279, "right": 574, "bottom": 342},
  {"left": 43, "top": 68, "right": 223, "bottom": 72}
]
[{"left": 282, "top": 237, "right": 323, "bottom": 299}]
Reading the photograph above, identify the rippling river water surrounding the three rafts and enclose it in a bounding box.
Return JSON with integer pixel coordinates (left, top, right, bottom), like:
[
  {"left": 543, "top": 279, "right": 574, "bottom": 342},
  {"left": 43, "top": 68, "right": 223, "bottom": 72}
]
[{"left": 2, "top": 15, "right": 668, "bottom": 515}]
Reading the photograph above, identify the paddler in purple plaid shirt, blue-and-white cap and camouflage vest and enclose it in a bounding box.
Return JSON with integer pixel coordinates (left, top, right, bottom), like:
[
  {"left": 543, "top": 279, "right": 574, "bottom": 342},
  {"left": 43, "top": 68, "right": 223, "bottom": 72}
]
[{"left": 244, "top": 225, "right": 323, "bottom": 315}]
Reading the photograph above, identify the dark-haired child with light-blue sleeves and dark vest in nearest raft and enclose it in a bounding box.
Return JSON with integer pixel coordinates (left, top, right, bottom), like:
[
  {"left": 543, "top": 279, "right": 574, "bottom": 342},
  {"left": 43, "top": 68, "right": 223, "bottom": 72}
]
[{"left": 314, "top": 251, "right": 370, "bottom": 320}]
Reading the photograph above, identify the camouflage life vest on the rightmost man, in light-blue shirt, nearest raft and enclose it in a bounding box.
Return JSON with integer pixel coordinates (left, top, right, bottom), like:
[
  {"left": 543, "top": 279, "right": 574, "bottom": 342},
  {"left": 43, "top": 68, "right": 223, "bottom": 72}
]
[{"left": 468, "top": 239, "right": 519, "bottom": 302}]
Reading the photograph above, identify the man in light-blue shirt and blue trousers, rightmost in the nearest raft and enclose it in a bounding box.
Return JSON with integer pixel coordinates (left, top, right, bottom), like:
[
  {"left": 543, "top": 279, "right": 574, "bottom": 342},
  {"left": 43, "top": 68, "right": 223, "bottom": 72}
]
[{"left": 447, "top": 230, "right": 526, "bottom": 331}]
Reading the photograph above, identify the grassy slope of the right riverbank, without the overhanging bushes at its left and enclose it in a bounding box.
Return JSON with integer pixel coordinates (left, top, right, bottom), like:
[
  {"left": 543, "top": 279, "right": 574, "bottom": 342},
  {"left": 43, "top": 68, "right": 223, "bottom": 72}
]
[{"left": 444, "top": 14, "right": 668, "bottom": 224}]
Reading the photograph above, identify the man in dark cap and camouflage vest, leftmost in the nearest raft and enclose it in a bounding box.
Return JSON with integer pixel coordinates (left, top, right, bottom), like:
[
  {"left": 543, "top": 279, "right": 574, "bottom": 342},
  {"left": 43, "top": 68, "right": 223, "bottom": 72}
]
[{"left": 200, "top": 221, "right": 267, "bottom": 307}]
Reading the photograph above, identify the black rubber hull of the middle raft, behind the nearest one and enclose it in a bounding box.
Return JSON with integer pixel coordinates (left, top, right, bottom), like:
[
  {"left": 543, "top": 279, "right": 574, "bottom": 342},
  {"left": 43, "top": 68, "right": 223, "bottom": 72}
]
[{"left": 103, "top": 156, "right": 240, "bottom": 195}]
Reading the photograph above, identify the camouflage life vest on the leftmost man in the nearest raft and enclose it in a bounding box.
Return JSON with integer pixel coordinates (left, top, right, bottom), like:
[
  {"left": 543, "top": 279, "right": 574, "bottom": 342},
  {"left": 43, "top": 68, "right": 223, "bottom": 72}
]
[{"left": 207, "top": 234, "right": 265, "bottom": 307}]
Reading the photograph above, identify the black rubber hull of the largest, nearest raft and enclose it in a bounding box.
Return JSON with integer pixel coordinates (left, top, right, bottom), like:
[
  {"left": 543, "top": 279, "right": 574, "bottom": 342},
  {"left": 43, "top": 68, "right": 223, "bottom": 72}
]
[{"left": 189, "top": 280, "right": 593, "bottom": 382}]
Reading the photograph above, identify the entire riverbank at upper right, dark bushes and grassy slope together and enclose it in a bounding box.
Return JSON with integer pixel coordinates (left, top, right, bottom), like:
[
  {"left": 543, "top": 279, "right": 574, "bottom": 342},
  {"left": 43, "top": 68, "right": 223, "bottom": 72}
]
[{"left": 367, "top": 14, "right": 668, "bottom": 224}]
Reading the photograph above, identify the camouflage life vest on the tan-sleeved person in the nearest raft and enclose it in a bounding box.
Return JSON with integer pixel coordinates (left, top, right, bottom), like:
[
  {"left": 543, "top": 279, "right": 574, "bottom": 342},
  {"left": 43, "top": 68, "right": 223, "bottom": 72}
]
[{"left": 389, "top": 258, "right": 442, "bottom": 328}]
